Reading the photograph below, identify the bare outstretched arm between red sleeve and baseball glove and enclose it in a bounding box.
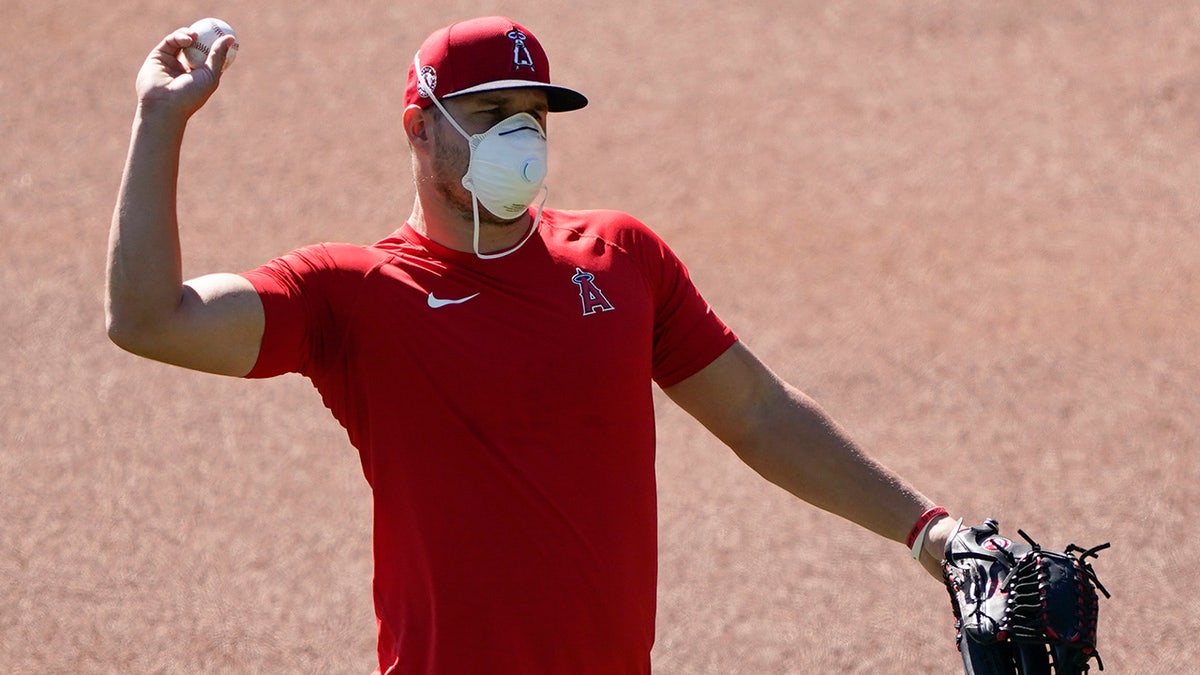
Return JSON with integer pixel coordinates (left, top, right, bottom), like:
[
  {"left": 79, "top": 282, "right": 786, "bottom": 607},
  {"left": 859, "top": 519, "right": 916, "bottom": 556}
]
[{"left": 666, "top": 342, "right": 954, "bottom": 579}]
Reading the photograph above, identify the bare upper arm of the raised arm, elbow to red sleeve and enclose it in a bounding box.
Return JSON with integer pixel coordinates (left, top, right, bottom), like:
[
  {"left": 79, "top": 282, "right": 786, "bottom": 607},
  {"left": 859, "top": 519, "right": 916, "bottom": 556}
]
[{"left": 114, "top": 274, "right": 266, "bottom": 377}]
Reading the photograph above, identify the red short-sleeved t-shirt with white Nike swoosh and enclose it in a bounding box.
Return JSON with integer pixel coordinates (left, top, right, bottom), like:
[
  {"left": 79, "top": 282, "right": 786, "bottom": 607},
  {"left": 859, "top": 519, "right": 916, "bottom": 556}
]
[{"left": 238, "top": 209, "right": 736, "bottom": 675}]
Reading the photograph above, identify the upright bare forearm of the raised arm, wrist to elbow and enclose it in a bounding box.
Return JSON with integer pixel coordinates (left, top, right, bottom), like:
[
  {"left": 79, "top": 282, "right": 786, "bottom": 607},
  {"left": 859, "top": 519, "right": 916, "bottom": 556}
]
[{"left": 107, "top": 107, "right": 186, "bottom": 339}]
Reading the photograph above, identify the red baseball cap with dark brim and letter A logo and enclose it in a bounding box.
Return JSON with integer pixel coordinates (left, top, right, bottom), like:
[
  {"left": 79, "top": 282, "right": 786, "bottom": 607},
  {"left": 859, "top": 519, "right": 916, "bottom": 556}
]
[{"left": 404, "top": 17, "right": 588, "bottom": 113}]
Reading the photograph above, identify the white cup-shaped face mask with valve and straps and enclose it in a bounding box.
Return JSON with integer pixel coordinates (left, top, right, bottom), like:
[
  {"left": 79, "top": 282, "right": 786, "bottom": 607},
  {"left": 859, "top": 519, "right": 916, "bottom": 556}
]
[{"left": 414, "top": 54, "right": 547, "bottom": 259}]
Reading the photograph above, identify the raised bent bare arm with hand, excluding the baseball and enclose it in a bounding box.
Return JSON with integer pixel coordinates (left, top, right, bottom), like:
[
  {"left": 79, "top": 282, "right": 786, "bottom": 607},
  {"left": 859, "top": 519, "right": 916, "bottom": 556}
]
[{"left": 104, "top": 29, "right": 264, "bottom": 376}]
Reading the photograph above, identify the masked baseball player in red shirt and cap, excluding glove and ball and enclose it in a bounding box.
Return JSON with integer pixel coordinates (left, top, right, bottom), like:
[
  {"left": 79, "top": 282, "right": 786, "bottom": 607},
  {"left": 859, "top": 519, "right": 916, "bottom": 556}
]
[{"left": 107, "top": 17, "right": 955, "bottom": 675}]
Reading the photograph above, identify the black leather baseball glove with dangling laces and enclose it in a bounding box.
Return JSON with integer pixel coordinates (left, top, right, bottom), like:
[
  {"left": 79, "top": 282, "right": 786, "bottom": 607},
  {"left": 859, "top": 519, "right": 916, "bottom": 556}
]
[{"left": 942, "top": 519, "right": 1109, "bottom": 675}]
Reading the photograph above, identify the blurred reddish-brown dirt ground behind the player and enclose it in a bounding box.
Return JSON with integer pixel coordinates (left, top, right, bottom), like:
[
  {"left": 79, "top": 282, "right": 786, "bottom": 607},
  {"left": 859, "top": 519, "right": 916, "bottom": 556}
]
[{"left": 0, "top": 0, "right": 1200, "bottom": 674}]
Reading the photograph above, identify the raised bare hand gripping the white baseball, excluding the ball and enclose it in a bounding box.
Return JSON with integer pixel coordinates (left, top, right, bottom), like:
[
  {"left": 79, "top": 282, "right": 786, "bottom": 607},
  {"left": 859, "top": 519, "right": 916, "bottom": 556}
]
[{"left": 137, "top": 28, "right": 235, "bottom": 120}]
